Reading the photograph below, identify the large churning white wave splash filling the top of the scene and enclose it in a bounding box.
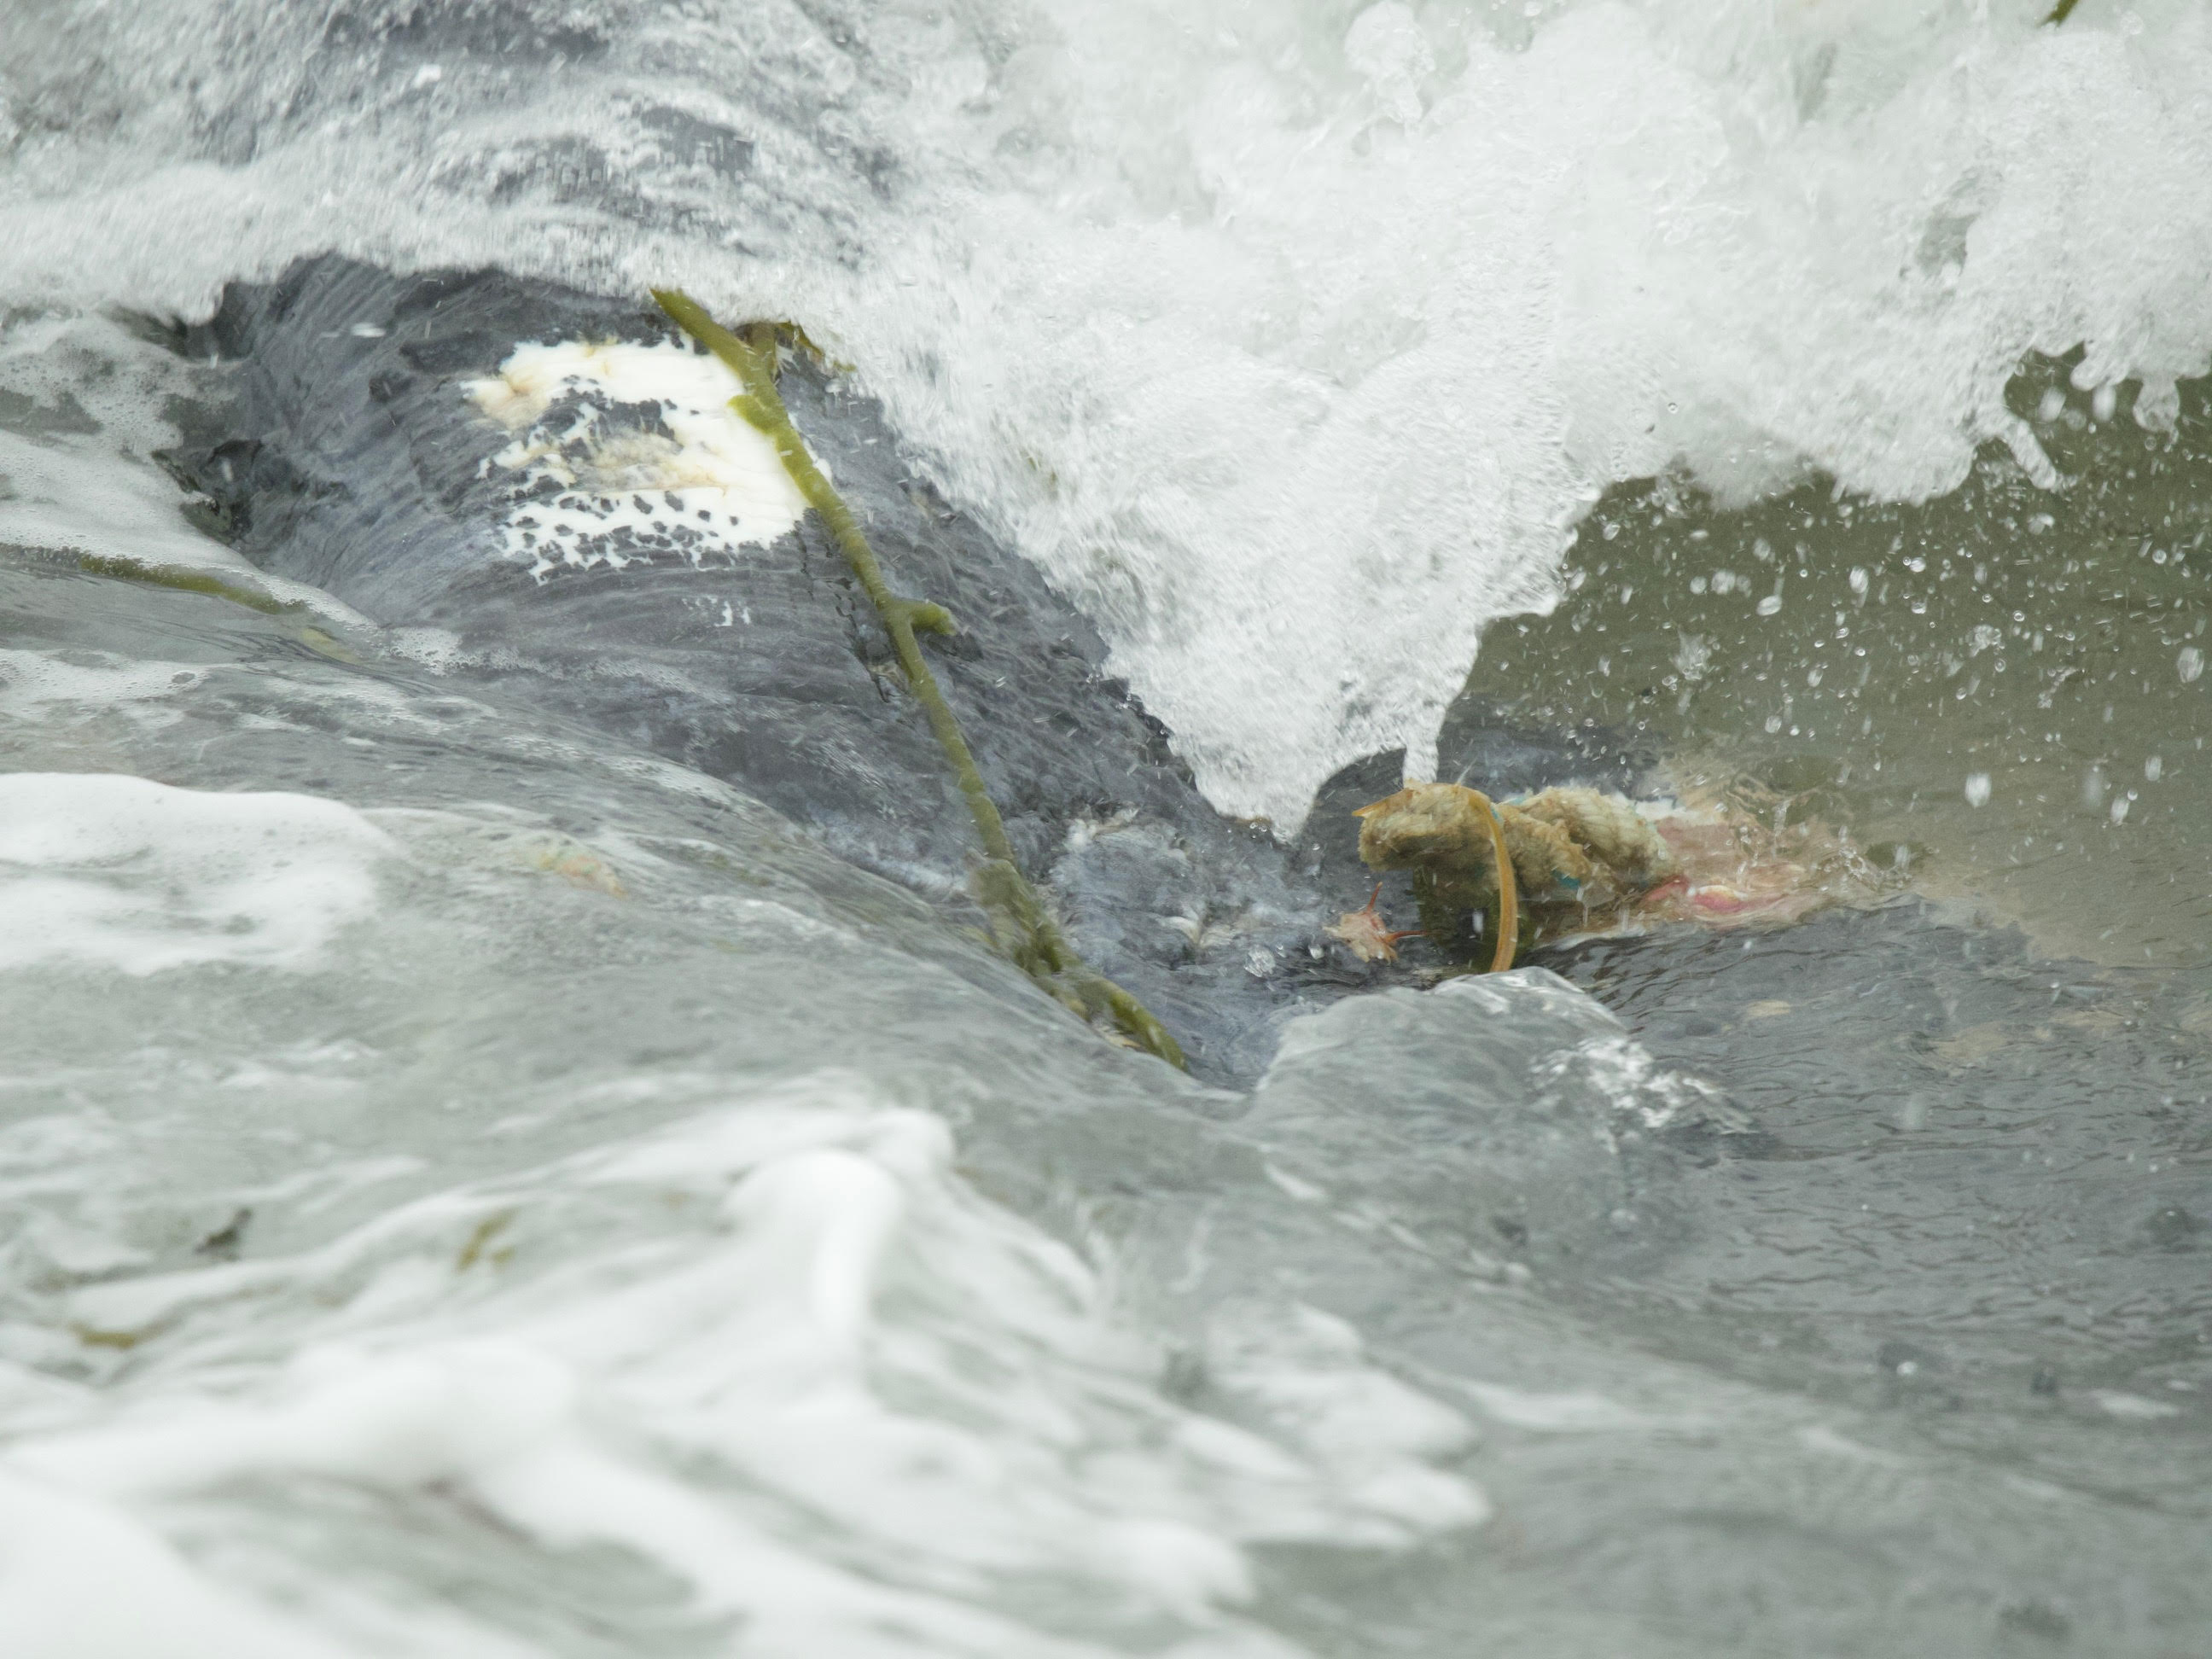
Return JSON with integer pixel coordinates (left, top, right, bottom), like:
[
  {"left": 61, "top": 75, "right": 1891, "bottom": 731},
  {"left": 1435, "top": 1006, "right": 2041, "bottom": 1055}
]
[{"left": 0, "top": 0, "right": 2212, "bottom": 823}]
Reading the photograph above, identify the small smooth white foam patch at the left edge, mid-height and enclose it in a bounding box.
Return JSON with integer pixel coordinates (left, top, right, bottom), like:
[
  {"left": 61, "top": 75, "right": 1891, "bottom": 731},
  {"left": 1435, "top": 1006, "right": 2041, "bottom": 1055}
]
[{"left": 0, "top": 772, "right": 399, "bottom": 973}]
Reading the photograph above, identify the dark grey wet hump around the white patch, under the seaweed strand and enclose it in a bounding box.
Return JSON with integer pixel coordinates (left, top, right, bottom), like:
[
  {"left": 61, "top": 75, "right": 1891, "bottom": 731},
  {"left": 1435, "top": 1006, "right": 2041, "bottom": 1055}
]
[{"left": 151, "top": 257, "right": 1633, "bottom": 1081}]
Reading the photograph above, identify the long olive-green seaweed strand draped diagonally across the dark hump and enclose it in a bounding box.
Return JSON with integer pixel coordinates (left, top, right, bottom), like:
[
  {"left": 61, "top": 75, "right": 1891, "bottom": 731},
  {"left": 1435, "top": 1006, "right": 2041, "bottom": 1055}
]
[{"left": 653, "top": 288, "right": 1184, "bottom": 1066}]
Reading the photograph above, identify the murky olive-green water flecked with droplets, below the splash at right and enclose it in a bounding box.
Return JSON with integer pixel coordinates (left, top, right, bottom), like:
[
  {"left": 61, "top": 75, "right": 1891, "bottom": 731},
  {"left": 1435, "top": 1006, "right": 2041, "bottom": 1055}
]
[{"left": 1469, "top": 363, "right": 2212, "bottom": 967}]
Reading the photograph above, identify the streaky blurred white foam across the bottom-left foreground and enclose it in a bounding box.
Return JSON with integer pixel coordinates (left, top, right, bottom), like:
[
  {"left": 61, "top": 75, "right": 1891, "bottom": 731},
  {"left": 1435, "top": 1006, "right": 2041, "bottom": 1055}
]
[{"left": 0, "top": 1073, "right": 1484, "bottom": 1659}]
